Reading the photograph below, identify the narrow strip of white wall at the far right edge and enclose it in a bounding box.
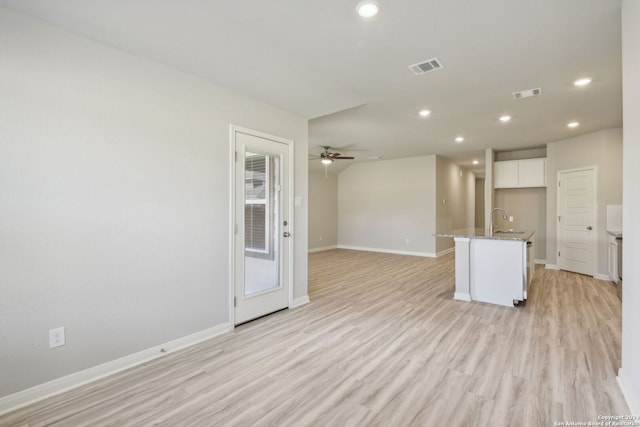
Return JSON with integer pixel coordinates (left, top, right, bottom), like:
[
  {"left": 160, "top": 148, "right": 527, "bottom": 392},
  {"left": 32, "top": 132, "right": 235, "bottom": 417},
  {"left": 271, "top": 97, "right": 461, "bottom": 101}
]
[{"left": 619, "top": 0, "right": 640, "bottom": 415}]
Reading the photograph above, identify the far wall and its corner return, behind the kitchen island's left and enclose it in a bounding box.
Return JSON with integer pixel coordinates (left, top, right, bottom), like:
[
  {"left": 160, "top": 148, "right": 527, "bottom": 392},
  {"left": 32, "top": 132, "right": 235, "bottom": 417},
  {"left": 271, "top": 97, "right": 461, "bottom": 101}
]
[{"left": 338, "top": 155, "right": 475, "bottom": 256}]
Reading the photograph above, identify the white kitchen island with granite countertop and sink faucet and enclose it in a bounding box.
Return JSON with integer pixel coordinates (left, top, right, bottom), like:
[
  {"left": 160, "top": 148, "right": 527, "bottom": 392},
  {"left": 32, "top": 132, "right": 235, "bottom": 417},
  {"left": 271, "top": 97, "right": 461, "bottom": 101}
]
[{"left": 434, "top": 228, "right": 535, "bottom": 306}]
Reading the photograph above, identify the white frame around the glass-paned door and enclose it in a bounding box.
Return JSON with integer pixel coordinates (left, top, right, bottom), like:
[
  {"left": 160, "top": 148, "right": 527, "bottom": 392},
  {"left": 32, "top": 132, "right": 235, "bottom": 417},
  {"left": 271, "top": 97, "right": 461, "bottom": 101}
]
[{"left": 228, "top": 124, "right": 295, "bottom": 328}]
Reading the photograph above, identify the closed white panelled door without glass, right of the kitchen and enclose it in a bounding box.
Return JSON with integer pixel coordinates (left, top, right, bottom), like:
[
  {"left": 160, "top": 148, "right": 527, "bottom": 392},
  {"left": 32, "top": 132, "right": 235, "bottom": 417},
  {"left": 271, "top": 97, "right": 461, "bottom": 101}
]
[{"left": 557, "top": 168, "right": 596, "bottom": 276}]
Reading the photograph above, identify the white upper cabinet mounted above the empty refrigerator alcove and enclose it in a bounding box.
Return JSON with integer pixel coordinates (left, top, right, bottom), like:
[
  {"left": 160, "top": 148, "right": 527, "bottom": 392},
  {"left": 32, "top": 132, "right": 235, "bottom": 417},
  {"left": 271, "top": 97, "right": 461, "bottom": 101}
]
[{"left": 493, "top": 158, "right": 547, "bottom": 188}]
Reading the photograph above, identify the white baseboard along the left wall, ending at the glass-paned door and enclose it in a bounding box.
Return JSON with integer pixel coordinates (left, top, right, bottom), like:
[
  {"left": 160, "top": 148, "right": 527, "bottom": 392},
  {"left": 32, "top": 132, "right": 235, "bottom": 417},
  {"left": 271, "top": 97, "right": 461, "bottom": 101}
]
[{"left": 0, "top": 323, "right": 233, "bottom": 415}]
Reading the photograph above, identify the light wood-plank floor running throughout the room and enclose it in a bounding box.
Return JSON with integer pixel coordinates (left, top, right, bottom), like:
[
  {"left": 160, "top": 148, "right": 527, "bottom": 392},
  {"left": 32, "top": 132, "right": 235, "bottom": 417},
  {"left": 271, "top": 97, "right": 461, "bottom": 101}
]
[{"left": 0, "top": 250, "right": 628, "bottom": 427}]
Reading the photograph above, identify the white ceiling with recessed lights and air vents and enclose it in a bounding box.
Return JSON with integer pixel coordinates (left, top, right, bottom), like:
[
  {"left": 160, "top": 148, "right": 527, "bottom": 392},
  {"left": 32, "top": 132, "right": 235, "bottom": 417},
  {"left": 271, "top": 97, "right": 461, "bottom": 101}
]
[{"left": 0, "top": 0, "right": 622, "bottom": 171}]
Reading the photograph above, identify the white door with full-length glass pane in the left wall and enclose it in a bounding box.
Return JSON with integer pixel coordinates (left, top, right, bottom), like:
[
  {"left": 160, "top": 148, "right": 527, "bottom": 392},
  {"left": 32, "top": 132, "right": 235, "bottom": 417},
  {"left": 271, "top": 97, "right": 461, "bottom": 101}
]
[{"left": 232, "top": 128, "right": 291, "bottom": 325}]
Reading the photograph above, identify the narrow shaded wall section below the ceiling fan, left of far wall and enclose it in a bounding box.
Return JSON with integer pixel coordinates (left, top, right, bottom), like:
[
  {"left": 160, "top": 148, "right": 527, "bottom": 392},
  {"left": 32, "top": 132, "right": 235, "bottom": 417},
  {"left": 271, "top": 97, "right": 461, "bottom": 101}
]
[{"left": 309, "top": 172, "right": 338, "bottom": 250}]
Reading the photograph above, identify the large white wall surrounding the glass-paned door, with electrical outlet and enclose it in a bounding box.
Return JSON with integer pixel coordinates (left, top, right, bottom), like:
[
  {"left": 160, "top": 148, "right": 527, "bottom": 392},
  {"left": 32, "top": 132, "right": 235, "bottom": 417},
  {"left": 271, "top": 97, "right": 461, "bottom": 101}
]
[{"left": 0, "top": 8, "right": 307, "bottom": 397}]
